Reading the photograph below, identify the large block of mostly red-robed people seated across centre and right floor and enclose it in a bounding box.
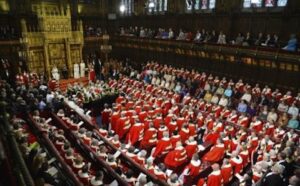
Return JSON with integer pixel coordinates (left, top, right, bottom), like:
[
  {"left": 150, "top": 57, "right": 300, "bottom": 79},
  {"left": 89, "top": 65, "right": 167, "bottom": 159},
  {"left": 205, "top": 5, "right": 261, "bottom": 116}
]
[{"left": 62, "top": 60, "right": 300, "bottom": 185}]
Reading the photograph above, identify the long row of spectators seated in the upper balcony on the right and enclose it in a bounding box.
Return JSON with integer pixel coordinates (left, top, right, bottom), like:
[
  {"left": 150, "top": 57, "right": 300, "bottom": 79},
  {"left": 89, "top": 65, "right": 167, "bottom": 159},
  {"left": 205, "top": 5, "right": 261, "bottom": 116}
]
[{"left": 120, "top": 27, "right": 298, "bottom": 51}]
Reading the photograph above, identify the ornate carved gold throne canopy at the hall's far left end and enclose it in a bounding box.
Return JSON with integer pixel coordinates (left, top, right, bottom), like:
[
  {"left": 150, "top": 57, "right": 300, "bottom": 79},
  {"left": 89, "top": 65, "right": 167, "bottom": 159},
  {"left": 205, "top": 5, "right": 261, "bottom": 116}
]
[{"left": 20, "top": 2, "right": 84, "bottom": 77}]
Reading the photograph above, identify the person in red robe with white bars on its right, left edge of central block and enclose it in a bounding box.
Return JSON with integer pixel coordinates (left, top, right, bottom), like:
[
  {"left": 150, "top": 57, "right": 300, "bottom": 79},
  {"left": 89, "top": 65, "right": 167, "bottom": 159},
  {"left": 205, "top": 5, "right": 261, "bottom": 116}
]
[{"left": 126, "top": 119, "right": 144, "bottom": 146}]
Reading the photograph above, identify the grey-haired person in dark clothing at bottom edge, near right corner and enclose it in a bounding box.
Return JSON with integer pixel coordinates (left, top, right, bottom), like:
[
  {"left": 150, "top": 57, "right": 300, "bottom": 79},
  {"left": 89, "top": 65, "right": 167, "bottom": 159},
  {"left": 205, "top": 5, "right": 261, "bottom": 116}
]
[{"left": 261, "top": 164, "right": 284, "bottom": 186}]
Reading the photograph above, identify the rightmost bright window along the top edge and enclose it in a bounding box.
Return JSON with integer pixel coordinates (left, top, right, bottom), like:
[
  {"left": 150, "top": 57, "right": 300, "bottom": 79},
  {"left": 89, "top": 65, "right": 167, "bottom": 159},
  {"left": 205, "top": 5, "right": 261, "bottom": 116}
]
[{"left": 243, "top": 0, "right": 288, "bottom": 8}]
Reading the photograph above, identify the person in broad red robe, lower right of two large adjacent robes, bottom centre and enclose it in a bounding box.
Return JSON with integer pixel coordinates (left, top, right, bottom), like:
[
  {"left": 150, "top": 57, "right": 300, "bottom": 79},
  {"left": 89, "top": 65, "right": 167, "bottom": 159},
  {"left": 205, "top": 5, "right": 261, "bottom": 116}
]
[{"left": 164, "top": 142, "right": 187, "bottom": 170}]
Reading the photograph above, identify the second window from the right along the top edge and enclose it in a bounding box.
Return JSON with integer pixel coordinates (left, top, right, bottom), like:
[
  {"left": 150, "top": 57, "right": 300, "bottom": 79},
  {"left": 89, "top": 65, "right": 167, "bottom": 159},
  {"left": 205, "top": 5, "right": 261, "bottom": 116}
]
[{"left": 186, "top": 0, "right": 216, "bottom": 11}]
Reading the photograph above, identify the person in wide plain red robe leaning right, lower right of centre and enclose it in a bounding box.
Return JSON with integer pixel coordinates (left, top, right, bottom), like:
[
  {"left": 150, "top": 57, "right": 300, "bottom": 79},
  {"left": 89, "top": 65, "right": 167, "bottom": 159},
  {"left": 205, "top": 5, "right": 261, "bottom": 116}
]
[{"left": 203, "top": 139, "right": 225, "bottom": 163}]
